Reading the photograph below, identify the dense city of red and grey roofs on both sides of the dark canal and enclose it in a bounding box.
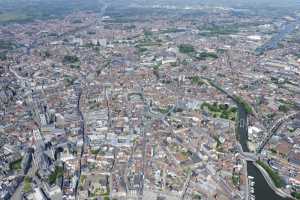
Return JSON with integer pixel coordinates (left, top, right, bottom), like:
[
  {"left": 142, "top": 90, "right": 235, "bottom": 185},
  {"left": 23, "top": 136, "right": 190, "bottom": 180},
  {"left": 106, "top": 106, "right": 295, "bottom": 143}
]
[{"left": 0, "top": 1, "right": 300, "bottom": 200}]
